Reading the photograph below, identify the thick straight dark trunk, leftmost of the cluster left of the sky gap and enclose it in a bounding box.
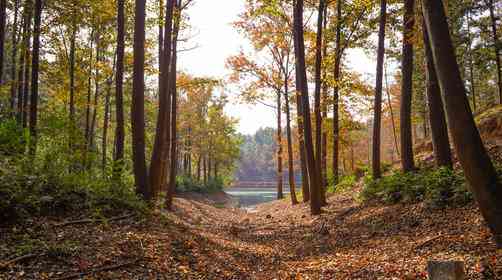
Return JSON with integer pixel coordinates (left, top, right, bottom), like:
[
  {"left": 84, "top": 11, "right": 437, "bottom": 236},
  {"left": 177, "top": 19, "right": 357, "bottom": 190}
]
[{"left": 131, "top": 0, "right": 152, "bottom": 200}]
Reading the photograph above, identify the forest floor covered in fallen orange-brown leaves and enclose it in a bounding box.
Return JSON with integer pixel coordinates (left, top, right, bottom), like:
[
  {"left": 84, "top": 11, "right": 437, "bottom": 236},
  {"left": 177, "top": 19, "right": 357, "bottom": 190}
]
[{"left": 0, "top": 185, "right": 502, "bottom": 279}]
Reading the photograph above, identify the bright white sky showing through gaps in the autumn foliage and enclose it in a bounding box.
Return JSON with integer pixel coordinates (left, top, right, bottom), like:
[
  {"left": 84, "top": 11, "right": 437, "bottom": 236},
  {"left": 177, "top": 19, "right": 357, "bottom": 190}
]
[{"left": 179, "top": 0, "right": 376, "bottom": 134}]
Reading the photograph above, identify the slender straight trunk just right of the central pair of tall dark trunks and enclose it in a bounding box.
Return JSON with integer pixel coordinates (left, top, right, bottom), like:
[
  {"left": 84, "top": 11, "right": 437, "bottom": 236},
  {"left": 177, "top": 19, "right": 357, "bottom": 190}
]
[{"left": 333, "top": 0, "right": 342, "bottom": 186}]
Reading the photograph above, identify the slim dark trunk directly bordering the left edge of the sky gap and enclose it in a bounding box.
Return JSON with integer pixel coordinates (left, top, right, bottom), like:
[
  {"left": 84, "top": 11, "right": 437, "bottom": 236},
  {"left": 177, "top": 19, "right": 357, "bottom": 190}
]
[{"left": 165, "top": 3, "right": 179, "bottom": 210}]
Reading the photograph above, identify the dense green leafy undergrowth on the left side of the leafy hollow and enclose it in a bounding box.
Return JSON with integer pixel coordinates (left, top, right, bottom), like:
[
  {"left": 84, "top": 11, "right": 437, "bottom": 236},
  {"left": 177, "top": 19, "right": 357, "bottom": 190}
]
[{"left": 0, "top": 121, "right": 148, "bottom": 223}]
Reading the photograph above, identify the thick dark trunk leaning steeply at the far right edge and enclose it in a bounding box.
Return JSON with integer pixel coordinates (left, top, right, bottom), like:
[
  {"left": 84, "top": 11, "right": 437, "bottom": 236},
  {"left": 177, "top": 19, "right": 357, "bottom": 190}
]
[{"left": 422, "top": 0, "right": 502, "bottom": 248}]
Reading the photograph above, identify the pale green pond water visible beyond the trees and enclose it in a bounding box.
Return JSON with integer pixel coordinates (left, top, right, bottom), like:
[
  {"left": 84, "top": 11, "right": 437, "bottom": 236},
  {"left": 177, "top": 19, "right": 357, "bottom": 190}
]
[{"left": 225, "top": 187, "right": 301, "bottom": 208}]
